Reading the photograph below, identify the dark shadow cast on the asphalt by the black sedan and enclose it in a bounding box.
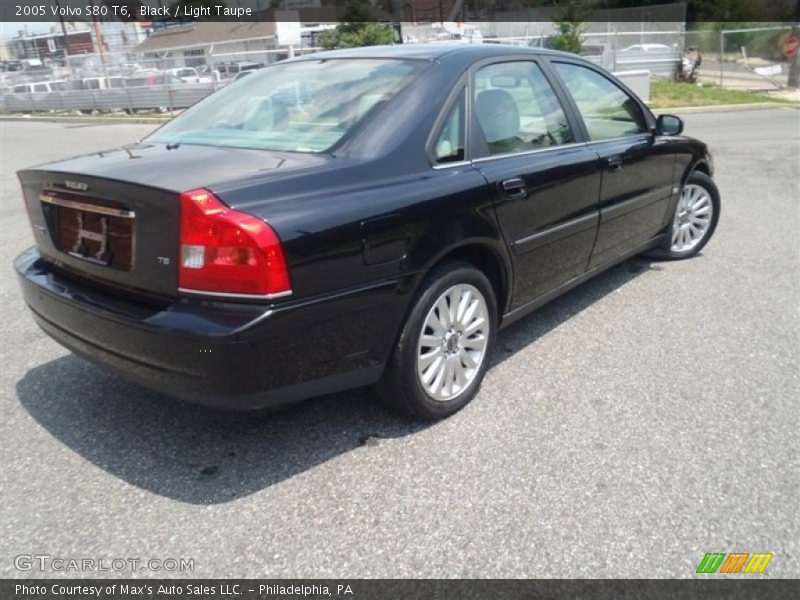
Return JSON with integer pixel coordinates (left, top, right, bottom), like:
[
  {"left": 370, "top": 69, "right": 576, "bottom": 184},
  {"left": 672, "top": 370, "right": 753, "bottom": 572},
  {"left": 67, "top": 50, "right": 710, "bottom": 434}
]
[{"left": 16, "top": 259, "right": 660, "bottom": 504}]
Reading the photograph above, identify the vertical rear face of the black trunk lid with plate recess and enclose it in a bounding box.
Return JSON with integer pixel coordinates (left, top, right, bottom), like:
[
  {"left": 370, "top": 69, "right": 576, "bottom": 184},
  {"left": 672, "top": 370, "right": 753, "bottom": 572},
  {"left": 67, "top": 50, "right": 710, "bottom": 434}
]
[{"left": 20, "top": 171, "right": 180, "bottom": 296}]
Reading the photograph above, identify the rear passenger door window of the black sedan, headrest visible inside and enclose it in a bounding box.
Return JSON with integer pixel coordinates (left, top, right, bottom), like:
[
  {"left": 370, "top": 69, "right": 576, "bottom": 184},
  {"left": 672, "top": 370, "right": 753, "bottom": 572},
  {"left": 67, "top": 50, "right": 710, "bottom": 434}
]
[{"left": 475, "top": 61, "right": 574, "bottom": 154}]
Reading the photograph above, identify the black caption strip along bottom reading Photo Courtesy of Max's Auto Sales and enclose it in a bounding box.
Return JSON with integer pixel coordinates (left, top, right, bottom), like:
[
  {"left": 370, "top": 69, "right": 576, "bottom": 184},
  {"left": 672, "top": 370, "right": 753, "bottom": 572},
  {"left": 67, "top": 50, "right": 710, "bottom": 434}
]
[{"left": 0, "top": 576, "right": 800, "bottom": 600}]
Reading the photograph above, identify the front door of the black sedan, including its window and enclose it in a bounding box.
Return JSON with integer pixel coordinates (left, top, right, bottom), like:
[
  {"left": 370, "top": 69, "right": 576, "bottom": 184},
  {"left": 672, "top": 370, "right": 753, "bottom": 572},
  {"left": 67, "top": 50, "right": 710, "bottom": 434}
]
[{"left": 551, "top": 60, "right": 675, "bottom": 268}]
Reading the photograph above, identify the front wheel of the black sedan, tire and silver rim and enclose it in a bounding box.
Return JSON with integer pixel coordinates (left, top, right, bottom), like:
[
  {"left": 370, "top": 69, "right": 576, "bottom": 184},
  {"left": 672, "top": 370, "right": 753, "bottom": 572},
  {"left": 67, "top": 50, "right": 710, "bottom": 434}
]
[{"left": 657, "top": 171, "right": 720, "bottom": 260}]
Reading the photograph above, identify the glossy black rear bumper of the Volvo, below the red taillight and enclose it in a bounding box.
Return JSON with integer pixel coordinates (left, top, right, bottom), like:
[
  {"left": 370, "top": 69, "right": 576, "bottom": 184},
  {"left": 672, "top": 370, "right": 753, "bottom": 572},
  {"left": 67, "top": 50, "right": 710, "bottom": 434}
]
[{"left": 14, "top": 248, "right": 404, "bottom": 410}]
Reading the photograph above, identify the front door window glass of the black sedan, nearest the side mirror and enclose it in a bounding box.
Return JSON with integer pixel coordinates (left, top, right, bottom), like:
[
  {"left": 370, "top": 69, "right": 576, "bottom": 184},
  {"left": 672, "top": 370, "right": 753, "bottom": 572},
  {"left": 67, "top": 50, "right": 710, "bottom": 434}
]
[{"left": 554, "top": 63, "right": 648, "bottom": 140}]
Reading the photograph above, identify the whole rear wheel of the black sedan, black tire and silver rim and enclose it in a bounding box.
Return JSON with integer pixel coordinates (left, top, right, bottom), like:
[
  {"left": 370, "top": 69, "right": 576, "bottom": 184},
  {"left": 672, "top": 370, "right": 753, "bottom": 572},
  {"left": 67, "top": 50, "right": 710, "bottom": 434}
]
[{"left": 378, "top": 261, "right": 497, "bottom": 420}]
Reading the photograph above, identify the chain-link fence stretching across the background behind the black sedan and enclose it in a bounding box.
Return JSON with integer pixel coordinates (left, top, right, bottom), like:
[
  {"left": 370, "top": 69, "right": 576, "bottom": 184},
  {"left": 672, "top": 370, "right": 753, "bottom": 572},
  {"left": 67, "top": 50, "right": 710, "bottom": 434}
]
[{"left": 0, "top": 22, "right": 791, "bottom": 114}]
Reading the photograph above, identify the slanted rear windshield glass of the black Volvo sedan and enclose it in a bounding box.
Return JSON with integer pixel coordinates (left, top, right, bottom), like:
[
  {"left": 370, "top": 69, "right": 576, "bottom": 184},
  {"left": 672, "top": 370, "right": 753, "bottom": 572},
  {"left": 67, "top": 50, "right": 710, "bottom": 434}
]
[{"left": 147, "top": 59, "right": 425, "bottom": 152}]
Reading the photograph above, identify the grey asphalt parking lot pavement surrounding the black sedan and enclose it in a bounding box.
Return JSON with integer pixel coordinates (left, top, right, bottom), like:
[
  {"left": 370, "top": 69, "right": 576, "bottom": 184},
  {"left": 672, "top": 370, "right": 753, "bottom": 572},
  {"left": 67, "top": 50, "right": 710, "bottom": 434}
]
[{"left": 0, "top": 108, "right": 800, "bottom": 578}]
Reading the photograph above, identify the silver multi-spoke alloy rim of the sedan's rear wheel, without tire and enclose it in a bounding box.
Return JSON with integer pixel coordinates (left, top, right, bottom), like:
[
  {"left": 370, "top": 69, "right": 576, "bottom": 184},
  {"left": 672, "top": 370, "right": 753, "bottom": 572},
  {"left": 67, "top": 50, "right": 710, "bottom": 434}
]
[{"left": 417, "top": 283, "right": 490, "bottom": 402}]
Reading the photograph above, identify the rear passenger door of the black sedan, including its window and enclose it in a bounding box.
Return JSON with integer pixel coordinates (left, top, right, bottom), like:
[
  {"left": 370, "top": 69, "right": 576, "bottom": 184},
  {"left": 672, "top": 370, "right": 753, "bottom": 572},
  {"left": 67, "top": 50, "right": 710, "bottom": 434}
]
[{"left": 471, "top": 57, "right": 601, "bottom": 310}]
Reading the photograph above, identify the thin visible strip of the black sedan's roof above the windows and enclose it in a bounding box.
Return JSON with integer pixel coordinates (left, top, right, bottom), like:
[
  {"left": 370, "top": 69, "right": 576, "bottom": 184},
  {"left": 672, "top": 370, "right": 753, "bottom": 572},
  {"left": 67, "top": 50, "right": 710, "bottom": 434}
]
[{"left": 295, "top": 44, "right": 575, "bottom": 60}]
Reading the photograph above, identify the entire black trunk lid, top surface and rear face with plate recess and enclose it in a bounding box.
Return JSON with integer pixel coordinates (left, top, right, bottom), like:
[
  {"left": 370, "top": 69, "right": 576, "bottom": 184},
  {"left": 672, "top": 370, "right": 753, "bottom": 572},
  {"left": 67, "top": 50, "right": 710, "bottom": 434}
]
[{"left": 18, "top": 144, "right": 325, "bottom": 297}]
